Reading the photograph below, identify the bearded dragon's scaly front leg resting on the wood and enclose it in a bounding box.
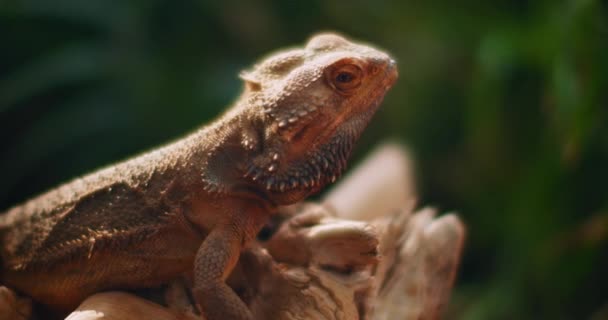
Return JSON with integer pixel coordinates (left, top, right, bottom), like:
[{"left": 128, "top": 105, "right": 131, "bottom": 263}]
[{"left": 193, "top": 212, "right": 261, "bottom": 320}]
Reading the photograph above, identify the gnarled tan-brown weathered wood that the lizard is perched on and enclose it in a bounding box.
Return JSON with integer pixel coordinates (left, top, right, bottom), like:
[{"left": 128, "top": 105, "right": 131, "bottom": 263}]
[{"left": 0, "top": 145, "right": 465, "bottom": 320}]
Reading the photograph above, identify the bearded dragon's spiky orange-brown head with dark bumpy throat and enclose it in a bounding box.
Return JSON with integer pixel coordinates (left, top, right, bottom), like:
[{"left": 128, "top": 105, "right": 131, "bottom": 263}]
[{"left": 241, "top": 34, "right": 397, "bottom": 204}]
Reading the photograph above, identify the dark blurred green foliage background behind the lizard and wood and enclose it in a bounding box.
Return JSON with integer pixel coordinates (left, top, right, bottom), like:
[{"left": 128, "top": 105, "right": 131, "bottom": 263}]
[{"left": 0, "top": 0, "right": 608, "bottom": 319}]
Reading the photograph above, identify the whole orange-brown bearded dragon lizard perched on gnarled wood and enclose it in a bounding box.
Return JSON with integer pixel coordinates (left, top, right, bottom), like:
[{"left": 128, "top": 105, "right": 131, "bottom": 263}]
[{"left": 0, "top": 34, "right": 397, "bottom": 320}]
